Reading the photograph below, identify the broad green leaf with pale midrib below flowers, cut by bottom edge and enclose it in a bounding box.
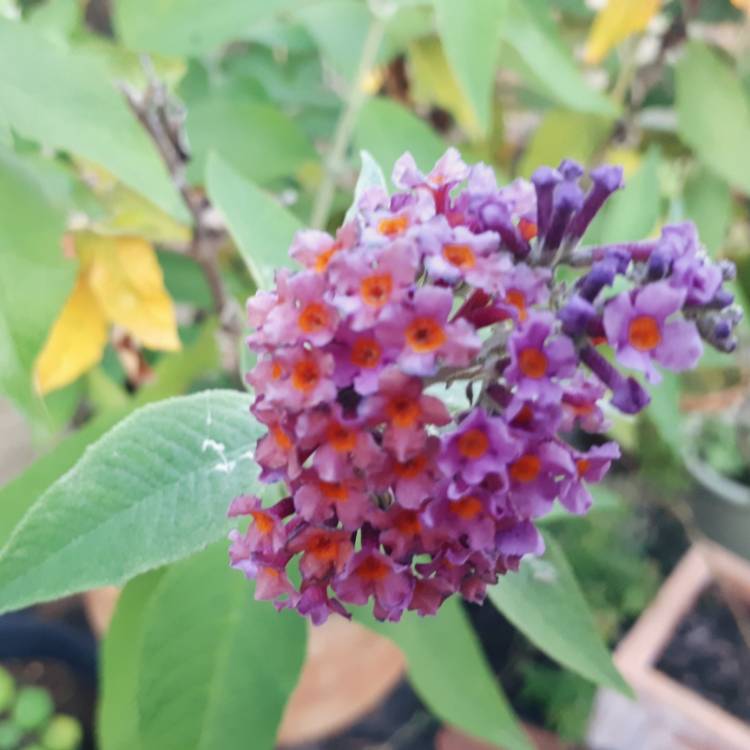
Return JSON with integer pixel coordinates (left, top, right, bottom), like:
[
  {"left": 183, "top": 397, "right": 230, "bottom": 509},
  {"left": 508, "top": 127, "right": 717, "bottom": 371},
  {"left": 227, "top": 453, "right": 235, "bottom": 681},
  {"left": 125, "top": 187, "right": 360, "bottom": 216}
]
[{"left": 138, "top": 543, "right": 306, "bottom": 750}]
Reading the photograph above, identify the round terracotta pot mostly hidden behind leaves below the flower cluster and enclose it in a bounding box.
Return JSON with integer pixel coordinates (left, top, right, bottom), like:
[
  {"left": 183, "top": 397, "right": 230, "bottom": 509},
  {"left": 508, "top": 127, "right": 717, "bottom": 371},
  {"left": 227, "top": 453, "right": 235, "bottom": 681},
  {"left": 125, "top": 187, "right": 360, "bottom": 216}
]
[{"left": 84, "top": 587, "right": 405, "bottom": 744}]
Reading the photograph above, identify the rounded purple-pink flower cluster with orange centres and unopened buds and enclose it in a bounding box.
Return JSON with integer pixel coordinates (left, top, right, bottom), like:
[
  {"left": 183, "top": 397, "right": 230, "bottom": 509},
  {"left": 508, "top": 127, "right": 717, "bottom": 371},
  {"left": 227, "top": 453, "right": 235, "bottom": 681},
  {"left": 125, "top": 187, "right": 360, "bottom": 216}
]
[{"left": 230, "top": 149, "right": 739, "bottom": 623}]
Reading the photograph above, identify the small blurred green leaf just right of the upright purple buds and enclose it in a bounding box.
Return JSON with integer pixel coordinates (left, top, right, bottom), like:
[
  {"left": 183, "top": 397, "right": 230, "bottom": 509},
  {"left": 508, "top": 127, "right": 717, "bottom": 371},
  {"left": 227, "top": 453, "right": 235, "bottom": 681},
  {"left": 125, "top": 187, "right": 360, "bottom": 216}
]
[{"left": 583, "top": 148, "right": 661, "bottom": 244}]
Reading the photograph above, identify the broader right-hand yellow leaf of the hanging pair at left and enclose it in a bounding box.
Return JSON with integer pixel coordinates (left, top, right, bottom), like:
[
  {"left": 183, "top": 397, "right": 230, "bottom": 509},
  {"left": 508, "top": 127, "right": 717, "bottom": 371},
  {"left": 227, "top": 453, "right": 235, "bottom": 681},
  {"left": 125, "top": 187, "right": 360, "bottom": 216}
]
[{"left": 76, "top": 232, "right": 180, "bottom": 351}]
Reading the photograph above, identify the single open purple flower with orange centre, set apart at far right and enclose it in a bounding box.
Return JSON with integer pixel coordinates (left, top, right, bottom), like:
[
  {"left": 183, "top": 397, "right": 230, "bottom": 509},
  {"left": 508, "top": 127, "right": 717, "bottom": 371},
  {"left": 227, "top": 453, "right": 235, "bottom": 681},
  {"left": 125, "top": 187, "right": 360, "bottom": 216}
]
[{"left": 604, "top": 281, "right": 703, "bottom": 383}]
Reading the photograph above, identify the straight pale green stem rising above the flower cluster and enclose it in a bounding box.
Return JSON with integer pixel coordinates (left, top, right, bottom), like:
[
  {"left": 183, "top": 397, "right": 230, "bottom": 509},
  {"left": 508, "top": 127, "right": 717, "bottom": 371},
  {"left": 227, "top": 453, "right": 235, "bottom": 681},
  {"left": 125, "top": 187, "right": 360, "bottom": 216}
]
[{"left": 310, "top": 17, "right": 385, "bottom": 229}]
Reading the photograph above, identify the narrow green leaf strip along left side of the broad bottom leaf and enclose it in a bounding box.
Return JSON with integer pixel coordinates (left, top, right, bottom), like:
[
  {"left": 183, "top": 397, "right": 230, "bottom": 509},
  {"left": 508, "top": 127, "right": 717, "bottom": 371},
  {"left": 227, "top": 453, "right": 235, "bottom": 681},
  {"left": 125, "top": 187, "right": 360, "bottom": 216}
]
[{"left": 96, "top": 568, "right": 166, "bottom": 750}]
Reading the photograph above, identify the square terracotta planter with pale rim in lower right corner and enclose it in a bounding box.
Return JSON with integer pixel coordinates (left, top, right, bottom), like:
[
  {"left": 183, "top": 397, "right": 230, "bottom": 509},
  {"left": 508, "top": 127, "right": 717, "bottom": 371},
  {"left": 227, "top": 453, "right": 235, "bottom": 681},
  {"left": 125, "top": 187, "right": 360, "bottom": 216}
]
[{"left": 588, "top": 542, "right": 750, "bottom": 750}]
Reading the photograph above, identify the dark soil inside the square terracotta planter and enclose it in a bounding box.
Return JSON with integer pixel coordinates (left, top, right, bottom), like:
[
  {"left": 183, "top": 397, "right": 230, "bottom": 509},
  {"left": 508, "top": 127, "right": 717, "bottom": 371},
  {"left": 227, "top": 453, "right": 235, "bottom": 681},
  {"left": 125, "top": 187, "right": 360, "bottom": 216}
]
[{"left": 656, "top": 585, "right": 750, "bottom": 721}]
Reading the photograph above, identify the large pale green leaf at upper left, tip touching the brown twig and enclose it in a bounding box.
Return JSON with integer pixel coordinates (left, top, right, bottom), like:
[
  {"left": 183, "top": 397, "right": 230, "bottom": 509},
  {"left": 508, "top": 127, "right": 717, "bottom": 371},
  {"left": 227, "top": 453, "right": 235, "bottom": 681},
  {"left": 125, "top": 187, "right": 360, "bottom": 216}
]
[{"left": 0, "top": 19, "right": 188, "bottom": 221}]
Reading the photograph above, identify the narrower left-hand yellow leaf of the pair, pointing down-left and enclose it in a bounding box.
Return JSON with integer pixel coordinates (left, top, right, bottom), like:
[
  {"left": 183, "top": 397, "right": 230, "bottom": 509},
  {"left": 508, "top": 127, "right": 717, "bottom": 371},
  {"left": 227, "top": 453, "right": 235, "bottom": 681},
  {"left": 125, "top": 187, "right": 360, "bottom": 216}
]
[{"left": 34, "top": 275, "right": 107, "bottom": 395}]
